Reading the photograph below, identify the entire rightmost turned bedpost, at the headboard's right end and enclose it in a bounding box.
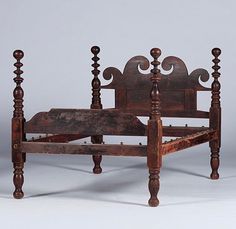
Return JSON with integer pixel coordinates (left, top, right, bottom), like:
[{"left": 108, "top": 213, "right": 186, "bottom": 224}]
[{"left": 210, "top": 48, "right": 221, "bottom": 179}]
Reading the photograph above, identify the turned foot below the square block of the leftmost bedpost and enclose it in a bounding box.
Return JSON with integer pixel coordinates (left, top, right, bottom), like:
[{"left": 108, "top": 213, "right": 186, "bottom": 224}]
[{"left": 13, "top": 162, "right": 24, "bottom": 199}]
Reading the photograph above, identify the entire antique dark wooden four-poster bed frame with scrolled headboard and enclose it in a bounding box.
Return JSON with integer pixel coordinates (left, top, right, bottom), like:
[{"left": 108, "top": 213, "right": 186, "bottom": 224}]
[{"left": 12, "top": 46, "right": 221, "bottom": 207}]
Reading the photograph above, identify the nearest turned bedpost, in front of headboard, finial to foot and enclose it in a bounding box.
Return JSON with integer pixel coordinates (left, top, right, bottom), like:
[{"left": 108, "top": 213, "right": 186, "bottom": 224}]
[{"left": 147, "top": 48, "right": 162, "bottom": 207}]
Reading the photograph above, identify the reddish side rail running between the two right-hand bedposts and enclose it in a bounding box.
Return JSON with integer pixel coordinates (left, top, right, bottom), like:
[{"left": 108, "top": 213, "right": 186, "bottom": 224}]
[{"left": 162, "top": 130, "right": 217, "bottom": 155}]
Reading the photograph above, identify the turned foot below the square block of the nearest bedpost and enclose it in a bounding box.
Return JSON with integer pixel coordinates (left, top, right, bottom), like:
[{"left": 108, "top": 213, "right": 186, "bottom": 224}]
[{"left": 148, "top": 169, "right": 160, "bottom": 207}]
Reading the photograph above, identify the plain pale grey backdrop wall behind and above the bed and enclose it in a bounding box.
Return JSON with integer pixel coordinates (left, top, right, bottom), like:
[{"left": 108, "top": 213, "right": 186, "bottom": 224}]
[{"left": 0, "top": 0, "right": 236, "bottom": 227}]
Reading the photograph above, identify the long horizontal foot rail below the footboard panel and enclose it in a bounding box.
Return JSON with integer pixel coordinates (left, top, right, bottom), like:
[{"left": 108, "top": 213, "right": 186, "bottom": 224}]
[{"left": 21, "top": 142, "right": 147, "bottom": 157}]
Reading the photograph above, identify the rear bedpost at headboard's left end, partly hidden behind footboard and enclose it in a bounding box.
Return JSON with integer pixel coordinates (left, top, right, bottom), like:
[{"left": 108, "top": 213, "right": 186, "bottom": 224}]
[{"left": 90, "top": 46, "right": 103, "bottom": 174}]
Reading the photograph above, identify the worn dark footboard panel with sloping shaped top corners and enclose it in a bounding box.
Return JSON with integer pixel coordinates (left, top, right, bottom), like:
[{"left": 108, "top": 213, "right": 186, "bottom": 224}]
[{"left": 25, "top": 109, "right": 146, "bottom": 136}]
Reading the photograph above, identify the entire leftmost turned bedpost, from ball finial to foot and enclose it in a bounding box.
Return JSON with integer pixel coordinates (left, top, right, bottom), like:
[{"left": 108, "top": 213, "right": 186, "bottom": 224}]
[{"left": 12, "top": 50, "right": 25, "bottom": 199}]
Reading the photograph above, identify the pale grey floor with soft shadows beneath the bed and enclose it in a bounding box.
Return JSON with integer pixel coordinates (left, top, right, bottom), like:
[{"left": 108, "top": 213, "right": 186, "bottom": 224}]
[{"left": 0, "top": 144, "right": 236, "bottom": 229}]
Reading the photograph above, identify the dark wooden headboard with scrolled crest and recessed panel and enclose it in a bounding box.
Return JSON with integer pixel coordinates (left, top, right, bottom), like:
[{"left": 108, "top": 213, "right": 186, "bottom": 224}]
[{"left": 101, "top": 56, "right": 211, "bottom": 118}]
